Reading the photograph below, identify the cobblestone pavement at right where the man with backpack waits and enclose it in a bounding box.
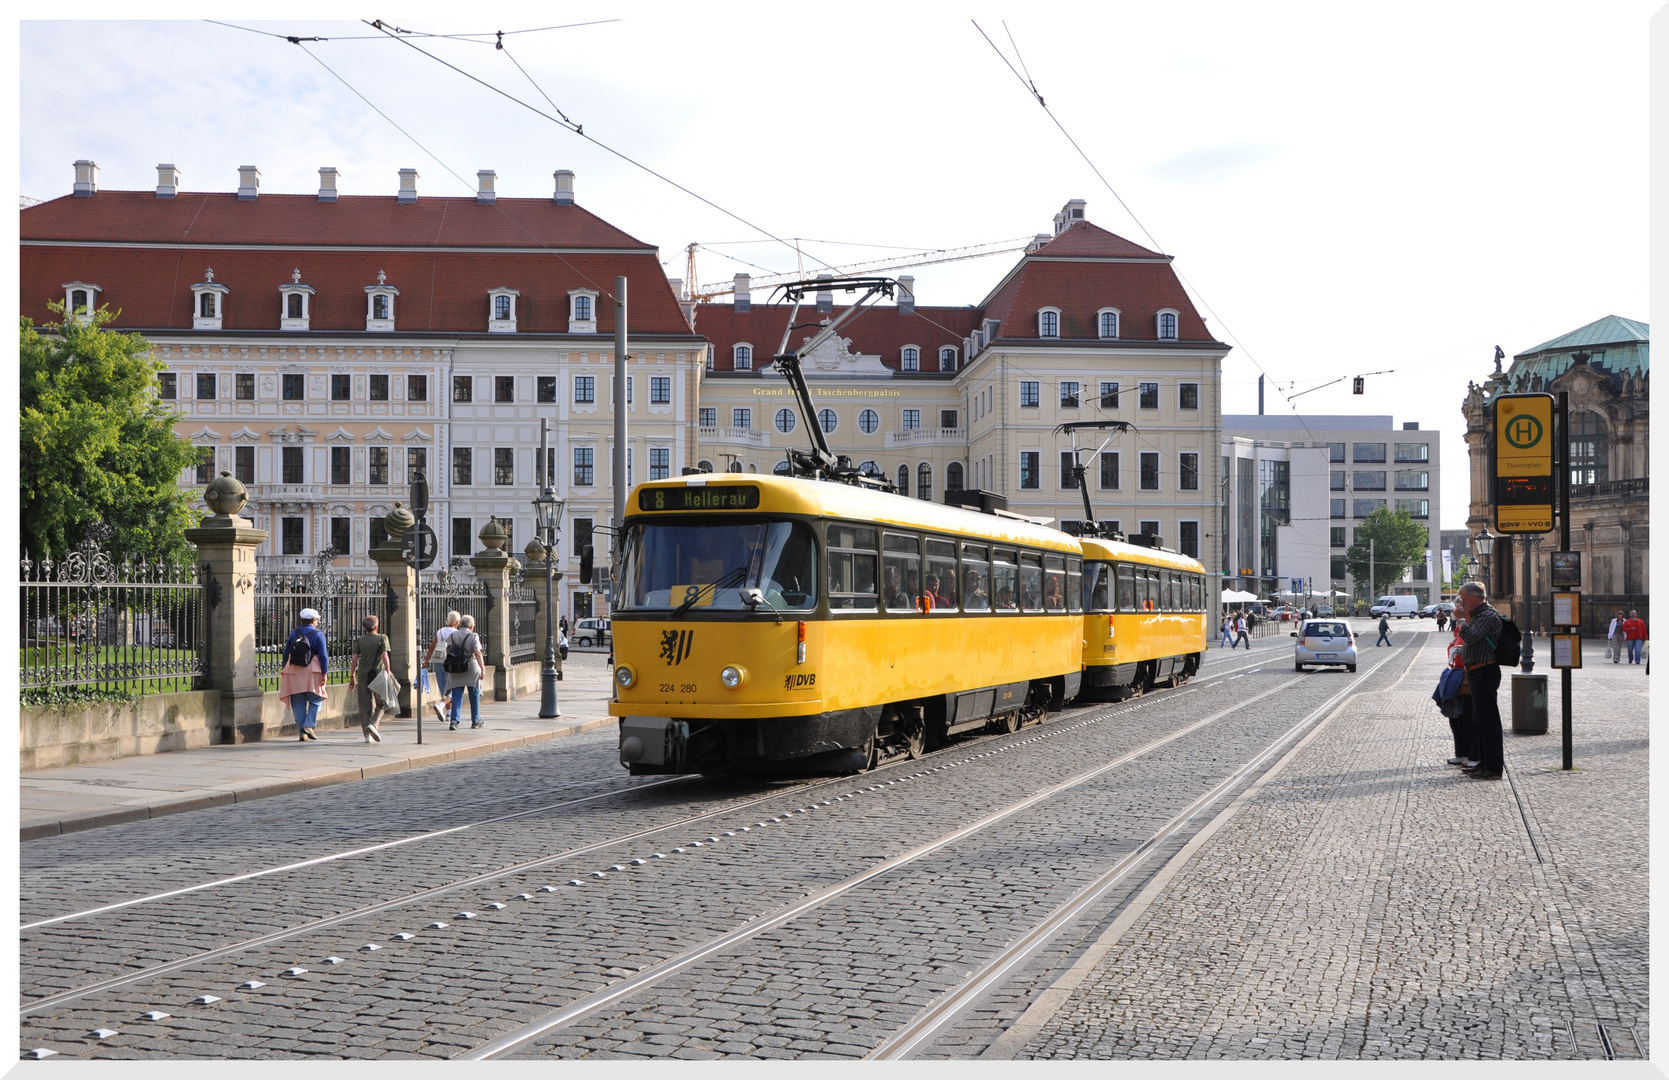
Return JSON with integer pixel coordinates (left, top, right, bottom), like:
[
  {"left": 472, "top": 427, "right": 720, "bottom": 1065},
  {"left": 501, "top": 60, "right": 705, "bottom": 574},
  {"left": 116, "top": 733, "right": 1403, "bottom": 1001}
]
[{"left": 968, "top": 643, "right": 1649, "bottom": 1058}]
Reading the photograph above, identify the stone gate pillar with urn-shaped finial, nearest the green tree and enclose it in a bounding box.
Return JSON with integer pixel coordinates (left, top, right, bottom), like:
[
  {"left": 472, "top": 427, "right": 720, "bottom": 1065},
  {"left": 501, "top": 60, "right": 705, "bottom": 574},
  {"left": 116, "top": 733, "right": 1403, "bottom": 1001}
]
[{"left": 185, "top": 472, "right": 267, "bottom": 743}]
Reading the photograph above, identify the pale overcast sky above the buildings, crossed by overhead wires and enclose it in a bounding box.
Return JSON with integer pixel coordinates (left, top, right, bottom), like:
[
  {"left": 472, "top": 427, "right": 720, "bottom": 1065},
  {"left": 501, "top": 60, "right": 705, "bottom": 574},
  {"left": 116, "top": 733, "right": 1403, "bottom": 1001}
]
[{"left": 20, "top": 2, "right": 1656, "bottom": 527}]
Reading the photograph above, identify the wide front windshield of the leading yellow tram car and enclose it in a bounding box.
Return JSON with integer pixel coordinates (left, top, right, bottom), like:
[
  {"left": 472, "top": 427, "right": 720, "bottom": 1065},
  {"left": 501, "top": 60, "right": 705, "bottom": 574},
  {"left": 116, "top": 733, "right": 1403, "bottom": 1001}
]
[{"left": 618, "top": 521, "right": 818, "bottom": 613}]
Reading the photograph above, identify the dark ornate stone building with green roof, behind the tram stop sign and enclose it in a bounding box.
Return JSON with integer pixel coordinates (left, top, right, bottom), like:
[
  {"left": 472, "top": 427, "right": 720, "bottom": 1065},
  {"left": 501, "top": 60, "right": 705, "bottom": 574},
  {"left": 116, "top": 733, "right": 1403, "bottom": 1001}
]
[{"left": 1460, "top": 315, "right": 1651, "bottom": 636}]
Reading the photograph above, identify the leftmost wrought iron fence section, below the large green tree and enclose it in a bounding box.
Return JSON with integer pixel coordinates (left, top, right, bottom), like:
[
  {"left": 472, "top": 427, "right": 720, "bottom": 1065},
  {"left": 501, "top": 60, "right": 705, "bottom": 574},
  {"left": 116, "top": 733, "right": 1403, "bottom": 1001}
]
[{"left": 18, "top": 541, "right": 205, "bottom": 693}]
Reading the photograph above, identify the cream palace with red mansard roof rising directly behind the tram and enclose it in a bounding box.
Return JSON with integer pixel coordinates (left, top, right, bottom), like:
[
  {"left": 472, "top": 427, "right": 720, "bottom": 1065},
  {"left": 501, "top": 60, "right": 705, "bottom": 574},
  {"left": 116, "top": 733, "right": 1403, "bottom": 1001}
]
[{"left": 694, "top": 199, "right": 1228, "bottom": 578}]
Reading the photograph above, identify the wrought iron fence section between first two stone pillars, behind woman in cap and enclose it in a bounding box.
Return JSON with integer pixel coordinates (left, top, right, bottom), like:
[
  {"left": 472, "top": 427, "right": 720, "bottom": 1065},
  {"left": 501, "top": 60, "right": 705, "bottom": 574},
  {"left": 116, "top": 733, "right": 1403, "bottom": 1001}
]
[{"left": 255, "top": 563, "right": 394, "bottom": 689}]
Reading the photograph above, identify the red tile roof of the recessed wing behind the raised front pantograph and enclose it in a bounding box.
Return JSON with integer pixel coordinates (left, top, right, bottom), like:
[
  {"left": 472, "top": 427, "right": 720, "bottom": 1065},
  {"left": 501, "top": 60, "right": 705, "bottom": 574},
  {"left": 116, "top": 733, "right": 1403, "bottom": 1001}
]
[{"left": 696, "top": 304, "right": 980, "bottom": 372}]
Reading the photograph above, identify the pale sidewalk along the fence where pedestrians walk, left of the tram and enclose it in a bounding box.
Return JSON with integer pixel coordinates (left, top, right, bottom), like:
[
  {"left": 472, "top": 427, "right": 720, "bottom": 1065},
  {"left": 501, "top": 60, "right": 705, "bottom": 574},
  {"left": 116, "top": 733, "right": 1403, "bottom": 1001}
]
[{"left": 18, "top": 651, "right": 616, "bottom": 840}]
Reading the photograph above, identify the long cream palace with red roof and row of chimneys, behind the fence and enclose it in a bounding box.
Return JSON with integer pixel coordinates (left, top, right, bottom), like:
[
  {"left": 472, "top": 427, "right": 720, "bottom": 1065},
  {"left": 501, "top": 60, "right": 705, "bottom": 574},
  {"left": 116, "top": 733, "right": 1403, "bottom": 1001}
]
[{"left": 20, "top": 162, "right": 708, "bottom": 614}]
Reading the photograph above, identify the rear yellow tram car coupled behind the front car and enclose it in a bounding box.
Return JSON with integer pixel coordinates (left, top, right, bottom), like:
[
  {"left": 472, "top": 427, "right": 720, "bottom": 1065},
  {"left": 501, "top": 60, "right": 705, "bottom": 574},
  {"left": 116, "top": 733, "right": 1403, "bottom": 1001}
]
[{"left": 1080, "top": 537, "right": 1210, "bottom": 699}]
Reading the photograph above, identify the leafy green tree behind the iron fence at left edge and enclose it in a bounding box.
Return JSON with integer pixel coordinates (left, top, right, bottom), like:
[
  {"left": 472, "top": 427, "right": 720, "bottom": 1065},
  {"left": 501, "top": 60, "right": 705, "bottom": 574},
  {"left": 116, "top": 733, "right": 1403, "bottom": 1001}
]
[{"left": 18, "top": 304, "right": 197, "bottom": 561}]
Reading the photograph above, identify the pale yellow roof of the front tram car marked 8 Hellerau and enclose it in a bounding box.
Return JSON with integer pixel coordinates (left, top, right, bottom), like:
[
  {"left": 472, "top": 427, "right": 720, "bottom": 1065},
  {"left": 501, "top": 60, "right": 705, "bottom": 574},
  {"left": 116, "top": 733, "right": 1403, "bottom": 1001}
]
[{"left": 626, "top": 472, "right": 1078, "bottom": 553}]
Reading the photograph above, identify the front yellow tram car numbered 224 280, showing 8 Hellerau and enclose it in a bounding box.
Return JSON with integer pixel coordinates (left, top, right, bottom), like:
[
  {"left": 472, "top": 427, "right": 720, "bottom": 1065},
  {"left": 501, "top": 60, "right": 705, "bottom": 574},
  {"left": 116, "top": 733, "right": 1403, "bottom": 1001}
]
[{"left": 609, "top": 474, "right": 1083, "bottom": 776}]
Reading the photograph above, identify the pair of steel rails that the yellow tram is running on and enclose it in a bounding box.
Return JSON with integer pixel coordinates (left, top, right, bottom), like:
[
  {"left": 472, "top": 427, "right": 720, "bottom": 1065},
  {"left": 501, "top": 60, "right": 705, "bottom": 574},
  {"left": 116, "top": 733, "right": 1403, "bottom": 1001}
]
[{"left": 18, "top": 647, "right": 1298, "bottom": 1017}]
